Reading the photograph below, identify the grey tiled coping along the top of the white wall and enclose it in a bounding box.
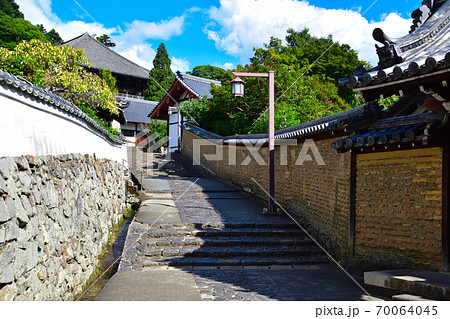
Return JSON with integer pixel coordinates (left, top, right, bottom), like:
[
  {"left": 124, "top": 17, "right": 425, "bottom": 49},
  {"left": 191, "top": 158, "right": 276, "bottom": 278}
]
[{"left": 0, "top": 70, "right": 121, "bottom": 142}]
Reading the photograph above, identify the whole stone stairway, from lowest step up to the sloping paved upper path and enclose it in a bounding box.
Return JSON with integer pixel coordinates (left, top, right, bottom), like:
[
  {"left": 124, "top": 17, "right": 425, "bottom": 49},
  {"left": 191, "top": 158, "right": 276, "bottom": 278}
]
[{"left": 127, "top": 153, "right": 329, "bottom": 269}]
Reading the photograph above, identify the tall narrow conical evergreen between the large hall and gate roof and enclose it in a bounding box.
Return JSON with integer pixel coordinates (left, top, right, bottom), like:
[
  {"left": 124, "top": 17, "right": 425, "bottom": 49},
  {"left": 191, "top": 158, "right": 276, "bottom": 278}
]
[{"left": 144, "top": 42, "right": 175, "bottom": 101}]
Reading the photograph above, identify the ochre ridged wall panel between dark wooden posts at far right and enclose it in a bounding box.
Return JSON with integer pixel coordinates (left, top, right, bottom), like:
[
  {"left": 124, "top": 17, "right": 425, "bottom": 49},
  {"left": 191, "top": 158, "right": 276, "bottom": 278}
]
[{"left": 355, "top": 147, "right": 442, "bottom": 269}]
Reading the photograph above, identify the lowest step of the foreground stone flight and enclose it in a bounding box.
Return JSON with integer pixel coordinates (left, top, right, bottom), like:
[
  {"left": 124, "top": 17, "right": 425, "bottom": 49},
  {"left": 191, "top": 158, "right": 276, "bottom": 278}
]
[{"left": 137, "top": 255, "right": 329, "bottom": 267}]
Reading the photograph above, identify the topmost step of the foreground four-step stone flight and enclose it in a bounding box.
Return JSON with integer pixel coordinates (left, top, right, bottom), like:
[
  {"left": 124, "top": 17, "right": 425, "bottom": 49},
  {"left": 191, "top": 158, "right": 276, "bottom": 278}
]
[{"left": 147, "top": 228, "right": 306, "bottom": 238}]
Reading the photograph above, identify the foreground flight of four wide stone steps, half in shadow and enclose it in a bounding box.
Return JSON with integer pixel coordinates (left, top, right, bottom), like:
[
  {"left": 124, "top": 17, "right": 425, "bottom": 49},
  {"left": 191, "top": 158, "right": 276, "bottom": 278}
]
[{"left": 138, "top": 224, "right": 329, "bottom": 268}]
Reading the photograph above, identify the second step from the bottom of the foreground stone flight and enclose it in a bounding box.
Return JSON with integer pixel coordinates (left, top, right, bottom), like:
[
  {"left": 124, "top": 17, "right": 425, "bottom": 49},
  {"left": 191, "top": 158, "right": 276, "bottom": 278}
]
[{"left": 145, "top": 246, "right": 323, "bottom": 258}]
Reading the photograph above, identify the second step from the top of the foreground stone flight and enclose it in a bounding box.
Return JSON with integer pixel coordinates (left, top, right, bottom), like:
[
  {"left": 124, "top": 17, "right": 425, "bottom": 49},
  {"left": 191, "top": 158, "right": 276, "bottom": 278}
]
[{"left": 147, "top": 236, "right": 314, "bottom": 247}]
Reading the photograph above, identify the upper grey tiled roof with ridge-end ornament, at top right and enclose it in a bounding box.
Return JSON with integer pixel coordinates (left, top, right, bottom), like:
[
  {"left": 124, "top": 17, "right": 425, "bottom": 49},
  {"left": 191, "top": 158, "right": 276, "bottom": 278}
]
[{"left": 339, "top": 0, "right": 450, "bottom": 89}]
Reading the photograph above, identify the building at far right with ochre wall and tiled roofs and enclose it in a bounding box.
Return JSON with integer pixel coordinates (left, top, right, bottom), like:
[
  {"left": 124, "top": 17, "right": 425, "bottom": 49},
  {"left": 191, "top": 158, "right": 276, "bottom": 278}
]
[{"left": 340, "top": 1, "right": 450, "bottom": 271}]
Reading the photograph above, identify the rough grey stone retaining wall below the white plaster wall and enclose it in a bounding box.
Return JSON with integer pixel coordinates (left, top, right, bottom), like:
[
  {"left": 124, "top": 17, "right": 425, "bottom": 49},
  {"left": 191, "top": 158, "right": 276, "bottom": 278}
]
[{"left": 0, "top": 155, "right": 125, "bottom": 300}]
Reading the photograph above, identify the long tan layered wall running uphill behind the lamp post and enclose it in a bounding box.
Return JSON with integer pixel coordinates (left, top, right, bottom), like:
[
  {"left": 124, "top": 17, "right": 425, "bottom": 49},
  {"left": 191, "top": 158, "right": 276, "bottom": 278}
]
[{"left": 182, "top": 130, "right": 350, "bottom": 258}]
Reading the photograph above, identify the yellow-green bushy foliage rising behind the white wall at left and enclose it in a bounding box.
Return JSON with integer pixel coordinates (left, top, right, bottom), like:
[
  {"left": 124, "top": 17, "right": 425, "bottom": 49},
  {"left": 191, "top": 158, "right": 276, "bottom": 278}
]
[{"left": 0, "top": 39, "right": 118, "bottom": 134}]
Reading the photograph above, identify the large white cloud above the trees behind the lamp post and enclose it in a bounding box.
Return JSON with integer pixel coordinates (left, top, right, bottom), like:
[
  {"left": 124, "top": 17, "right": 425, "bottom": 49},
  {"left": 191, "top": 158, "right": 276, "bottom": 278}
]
[{"left": 205, "top": 0, "right": 411, "bottom": 64}]
